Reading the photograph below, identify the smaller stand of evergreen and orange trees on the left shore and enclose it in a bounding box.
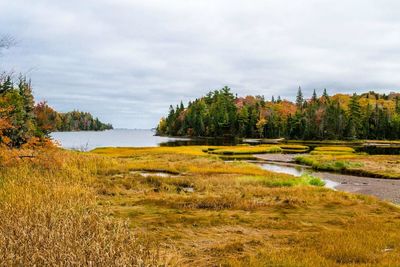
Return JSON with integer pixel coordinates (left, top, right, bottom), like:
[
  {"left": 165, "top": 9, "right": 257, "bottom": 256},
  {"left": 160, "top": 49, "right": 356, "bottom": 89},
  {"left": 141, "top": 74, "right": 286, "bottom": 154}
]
[{"left": 0, "top": 74, "right": 112, "bottom": 147}]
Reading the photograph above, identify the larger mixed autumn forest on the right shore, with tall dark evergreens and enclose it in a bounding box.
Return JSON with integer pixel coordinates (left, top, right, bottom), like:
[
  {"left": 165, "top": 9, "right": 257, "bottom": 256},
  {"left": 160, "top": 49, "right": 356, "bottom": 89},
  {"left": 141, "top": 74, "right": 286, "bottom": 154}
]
[{"left": 157, "top": 87, "right": 400, "bottom": 140}]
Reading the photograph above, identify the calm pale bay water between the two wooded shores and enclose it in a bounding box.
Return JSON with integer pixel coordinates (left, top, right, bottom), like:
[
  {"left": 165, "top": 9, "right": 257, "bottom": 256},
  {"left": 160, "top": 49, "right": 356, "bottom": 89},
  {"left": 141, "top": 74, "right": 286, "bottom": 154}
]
[{"left": 51, "top": 129, "right": 236, "bottom": 151}]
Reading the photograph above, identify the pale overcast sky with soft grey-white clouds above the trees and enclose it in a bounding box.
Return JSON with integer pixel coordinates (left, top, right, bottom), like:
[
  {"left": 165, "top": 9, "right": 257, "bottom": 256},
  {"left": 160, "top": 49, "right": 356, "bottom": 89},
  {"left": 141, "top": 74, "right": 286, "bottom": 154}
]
[{"left": 0, "top": 0, "right": 400, "bottom": 128}]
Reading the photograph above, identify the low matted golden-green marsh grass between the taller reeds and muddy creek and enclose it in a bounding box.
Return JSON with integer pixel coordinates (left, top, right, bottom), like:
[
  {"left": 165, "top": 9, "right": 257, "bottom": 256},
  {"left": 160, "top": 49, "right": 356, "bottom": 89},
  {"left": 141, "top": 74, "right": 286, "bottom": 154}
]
[{"left": 94, "top": 148, "right": 400, "bottom": 266}]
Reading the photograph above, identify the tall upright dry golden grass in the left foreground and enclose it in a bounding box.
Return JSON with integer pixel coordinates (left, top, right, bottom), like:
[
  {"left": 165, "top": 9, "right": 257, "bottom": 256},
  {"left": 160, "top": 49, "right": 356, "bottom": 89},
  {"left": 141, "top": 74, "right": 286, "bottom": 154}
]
[{"left": 0, "top": 149, "right": 166, "bottom": 266}]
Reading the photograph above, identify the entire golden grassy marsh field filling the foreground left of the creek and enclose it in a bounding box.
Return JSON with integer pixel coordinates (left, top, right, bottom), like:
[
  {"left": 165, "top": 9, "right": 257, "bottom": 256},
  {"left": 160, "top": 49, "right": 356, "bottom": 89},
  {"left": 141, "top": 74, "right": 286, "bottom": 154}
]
[{"left": 0, "top": 147, "right": 400, "bottom": 266}]
